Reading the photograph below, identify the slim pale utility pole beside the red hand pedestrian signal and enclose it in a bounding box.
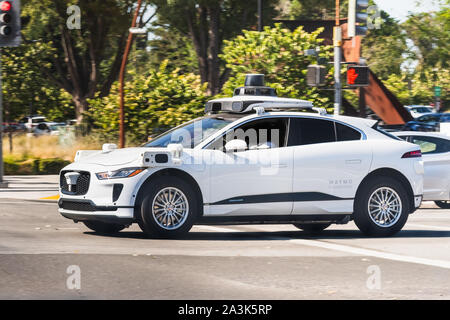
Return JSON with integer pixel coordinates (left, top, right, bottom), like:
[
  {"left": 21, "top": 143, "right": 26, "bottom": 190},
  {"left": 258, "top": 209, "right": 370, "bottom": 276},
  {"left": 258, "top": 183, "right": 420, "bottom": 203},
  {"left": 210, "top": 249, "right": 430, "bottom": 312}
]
[{"left": 333, "top": 0, "right": 342, "bottom": 115}]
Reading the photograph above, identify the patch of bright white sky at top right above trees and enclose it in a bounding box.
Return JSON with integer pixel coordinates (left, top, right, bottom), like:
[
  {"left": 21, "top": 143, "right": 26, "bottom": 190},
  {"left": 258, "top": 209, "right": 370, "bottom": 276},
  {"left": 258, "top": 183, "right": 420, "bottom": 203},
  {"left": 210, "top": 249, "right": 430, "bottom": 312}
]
[{"left": 375, "top": 0, "right": 439, "bottom": 22}]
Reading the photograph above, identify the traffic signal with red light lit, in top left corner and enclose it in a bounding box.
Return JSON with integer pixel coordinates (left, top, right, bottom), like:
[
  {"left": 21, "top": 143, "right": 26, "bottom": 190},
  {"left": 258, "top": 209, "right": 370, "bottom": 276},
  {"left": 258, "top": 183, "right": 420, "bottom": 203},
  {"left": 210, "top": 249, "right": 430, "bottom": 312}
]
[{"left": 0, "top": 0, "right": 21, "bottom": 47}]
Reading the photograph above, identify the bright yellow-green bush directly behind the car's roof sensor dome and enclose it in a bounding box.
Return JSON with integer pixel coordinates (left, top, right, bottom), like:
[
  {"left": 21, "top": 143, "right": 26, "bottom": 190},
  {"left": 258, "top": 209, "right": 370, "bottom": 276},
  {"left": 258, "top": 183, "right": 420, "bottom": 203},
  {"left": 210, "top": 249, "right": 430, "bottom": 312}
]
[{"left": 221, "top": 24, "right": 332, "bottom": 107}]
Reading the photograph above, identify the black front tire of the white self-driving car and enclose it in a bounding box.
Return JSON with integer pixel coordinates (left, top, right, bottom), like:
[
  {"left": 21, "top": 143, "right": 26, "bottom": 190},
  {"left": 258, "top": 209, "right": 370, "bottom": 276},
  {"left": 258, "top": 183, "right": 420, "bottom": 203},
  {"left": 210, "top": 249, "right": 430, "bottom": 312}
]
[{"left": 139, "top": 176, "right": 200, "bottom": 239}]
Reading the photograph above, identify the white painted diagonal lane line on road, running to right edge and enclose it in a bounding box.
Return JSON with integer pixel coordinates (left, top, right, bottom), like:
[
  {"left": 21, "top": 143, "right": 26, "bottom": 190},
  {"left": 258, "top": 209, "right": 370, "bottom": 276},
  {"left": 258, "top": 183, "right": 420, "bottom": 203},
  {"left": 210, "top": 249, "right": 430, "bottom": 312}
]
[{"left": 199, "top": 226, "right": 450, "bottom": 269}]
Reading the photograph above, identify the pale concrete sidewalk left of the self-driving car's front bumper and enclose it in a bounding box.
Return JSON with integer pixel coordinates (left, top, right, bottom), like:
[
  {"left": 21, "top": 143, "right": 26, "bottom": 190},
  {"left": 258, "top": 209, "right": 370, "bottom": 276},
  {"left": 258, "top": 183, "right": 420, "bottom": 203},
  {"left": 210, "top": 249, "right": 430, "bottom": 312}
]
[{"left": 0, "top": 175, "right": 59, "bottom": 201}]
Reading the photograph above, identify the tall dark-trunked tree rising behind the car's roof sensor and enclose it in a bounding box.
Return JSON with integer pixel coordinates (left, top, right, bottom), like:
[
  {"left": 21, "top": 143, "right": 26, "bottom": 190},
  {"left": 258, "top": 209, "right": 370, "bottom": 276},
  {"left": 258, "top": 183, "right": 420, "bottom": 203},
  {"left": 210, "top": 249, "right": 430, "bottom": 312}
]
[{"left": 151, "top": 0, "right": 278, "bottom": 95}]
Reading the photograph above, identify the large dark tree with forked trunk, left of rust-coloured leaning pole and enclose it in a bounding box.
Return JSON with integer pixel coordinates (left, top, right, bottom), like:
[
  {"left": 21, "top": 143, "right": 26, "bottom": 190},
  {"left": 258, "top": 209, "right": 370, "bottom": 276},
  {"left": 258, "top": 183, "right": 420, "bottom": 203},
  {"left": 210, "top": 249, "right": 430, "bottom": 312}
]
[{"left": 23, "top": 0, "right": 154, "bottom": 121}]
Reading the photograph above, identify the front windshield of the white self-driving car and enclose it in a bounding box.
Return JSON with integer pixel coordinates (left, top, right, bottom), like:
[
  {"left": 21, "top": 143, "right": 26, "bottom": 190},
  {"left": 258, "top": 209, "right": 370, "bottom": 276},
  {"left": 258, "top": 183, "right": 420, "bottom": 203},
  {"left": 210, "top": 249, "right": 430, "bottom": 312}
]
[{"left": 144, "top": 116, "right": 234, "bottom": 148}]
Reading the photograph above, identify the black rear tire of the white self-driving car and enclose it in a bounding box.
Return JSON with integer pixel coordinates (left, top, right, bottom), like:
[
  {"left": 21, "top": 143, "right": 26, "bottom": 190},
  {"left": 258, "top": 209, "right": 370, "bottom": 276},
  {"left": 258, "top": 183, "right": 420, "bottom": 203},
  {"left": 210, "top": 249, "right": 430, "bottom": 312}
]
[{"left": 353, "top": 176, "right": 411, "bottom": 237}]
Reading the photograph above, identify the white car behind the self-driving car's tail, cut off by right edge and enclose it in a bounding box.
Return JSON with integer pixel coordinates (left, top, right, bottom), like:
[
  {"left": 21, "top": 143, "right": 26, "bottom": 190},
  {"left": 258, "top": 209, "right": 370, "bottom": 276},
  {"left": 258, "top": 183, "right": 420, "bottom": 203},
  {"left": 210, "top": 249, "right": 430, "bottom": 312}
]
[{"left": 394, "top": 131, "right": 450, "bottom": 209}]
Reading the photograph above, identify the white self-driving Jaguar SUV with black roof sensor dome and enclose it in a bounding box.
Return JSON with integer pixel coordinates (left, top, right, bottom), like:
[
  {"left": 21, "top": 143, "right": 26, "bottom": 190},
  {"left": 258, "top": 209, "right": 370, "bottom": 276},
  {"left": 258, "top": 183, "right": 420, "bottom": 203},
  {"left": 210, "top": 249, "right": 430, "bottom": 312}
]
[{"left": 58, "top": 75, "right": 423, "bottom": 237}]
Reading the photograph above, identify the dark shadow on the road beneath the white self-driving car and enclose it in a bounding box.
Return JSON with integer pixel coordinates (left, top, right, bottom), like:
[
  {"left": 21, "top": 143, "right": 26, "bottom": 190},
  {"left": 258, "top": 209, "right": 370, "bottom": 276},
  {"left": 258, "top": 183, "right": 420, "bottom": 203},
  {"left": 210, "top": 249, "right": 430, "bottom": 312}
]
[{"left": 84, "top": 230, "right": 450, "bottom": 241}]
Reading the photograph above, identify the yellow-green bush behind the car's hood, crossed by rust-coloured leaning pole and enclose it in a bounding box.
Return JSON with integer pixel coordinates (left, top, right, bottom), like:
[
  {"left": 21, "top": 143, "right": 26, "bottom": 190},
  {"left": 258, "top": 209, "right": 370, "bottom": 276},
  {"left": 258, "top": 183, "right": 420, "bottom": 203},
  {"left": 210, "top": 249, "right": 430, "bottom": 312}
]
[{"left": 87, "top": 61, "right": 208, "bottom": 143}]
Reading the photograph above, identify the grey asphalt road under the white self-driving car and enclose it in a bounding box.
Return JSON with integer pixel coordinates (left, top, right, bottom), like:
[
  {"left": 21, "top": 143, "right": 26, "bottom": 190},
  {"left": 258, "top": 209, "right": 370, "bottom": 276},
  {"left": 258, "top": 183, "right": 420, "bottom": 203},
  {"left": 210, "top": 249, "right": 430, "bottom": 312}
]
[{"left": 0, "top": 199, "right": 450, "bottom": 299}]
